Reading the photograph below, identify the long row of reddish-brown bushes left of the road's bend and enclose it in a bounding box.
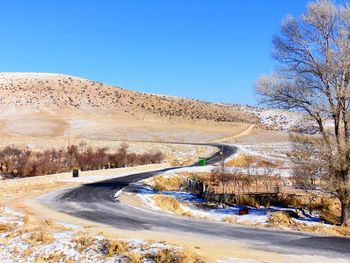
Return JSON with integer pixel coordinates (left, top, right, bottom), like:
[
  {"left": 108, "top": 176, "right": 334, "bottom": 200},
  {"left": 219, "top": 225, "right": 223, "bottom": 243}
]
[{"left": 0, "top": 143, "right": 164, "bottom": 178}]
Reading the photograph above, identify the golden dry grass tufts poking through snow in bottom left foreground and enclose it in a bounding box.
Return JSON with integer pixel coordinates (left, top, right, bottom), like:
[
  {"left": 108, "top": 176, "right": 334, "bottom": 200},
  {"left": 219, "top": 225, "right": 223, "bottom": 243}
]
[{"left": 0, "top": 205, "right": 206, "bottom": 263}]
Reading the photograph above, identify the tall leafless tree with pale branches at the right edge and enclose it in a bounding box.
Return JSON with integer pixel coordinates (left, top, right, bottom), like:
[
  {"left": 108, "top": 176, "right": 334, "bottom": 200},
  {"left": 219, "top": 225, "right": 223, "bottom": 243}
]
[{"left": 256, "top": 0, "right": 350, "bottom": 225}]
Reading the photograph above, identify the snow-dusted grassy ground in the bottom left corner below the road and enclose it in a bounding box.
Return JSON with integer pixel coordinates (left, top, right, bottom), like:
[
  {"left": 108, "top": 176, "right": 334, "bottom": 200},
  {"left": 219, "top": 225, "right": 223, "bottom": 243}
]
[{"left": 0, "top": 207, "right": 191, "bottom": 263}]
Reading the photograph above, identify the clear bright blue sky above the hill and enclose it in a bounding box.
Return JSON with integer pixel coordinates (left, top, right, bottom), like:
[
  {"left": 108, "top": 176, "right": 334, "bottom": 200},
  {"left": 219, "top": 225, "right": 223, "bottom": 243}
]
[{"left": 0, "top": 0, "right": 307, "bottom": 104}]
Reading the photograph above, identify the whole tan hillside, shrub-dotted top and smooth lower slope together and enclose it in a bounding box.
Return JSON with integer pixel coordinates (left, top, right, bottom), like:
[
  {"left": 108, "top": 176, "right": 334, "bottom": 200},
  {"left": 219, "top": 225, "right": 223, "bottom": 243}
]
[{"left": 0, "top": 73, "right": 298, "bottom": 146}]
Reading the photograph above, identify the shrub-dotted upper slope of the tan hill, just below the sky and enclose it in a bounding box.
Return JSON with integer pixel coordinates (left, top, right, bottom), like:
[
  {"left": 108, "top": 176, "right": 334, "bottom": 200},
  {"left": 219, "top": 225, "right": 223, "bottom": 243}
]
[{"left": 0, "top": 73, "right": 258, "bottom": 123}]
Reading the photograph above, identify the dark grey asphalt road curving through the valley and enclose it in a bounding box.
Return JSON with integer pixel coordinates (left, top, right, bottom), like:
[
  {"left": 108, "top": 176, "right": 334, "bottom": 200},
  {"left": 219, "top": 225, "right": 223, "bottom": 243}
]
[{"left": 38, "top": 144, "right": 350, "bottom": 262}]
